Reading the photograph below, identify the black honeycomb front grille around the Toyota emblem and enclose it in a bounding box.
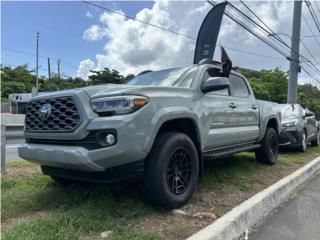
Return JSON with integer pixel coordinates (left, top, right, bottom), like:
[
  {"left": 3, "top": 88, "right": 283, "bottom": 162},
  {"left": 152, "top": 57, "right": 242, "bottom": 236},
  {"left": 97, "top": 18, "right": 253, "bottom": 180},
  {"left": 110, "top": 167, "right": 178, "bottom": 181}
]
[{"left": 25, "top": 97, "right": 81, "bottom": 132}]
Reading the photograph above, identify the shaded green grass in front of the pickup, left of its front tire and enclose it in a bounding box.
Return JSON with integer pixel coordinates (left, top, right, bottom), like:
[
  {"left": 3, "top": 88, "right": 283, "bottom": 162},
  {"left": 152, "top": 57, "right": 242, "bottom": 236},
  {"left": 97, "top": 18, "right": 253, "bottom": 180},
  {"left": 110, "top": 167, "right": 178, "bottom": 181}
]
[{"left": 1, "top": 174, "right": 154, "bottom": 240}]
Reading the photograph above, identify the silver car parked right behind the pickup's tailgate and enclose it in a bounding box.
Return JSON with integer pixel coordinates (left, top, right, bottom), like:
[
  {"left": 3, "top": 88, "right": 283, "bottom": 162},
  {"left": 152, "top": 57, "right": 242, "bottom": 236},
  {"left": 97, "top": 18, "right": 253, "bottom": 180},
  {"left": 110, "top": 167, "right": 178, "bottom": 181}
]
[{"left": 279, "top": 104, "right": 320, "bottom": 152}]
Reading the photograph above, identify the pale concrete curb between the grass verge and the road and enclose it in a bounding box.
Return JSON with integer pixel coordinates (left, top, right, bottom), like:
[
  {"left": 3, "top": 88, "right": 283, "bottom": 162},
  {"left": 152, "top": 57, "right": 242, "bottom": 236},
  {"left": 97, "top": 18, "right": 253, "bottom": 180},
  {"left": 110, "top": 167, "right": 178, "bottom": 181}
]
[{"left": 187, "top": 157, "right": 320, "bottom": 240}]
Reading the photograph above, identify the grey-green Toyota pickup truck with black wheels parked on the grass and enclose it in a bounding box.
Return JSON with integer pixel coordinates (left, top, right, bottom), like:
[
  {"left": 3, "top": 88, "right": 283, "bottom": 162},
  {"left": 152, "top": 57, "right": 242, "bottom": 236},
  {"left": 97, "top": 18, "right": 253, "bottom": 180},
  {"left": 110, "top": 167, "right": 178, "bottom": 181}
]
[{"left": 19, "top": 60, "right": 281, "bottom": 209}]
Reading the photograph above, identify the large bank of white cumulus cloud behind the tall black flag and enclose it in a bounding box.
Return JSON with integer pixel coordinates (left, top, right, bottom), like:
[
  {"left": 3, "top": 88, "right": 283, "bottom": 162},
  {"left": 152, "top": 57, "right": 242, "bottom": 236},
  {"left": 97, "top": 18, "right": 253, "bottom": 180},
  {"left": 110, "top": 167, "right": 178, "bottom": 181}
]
[{"left": 79, "top": 0, "right": 320, "bottom": 85}]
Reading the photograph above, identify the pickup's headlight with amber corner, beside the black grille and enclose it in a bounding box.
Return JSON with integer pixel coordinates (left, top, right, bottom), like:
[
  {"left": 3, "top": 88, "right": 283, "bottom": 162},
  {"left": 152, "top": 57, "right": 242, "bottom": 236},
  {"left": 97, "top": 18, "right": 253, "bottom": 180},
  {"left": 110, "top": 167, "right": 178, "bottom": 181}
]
[{"left": 90, "top": 96, "right": 148, "bottom": 115}]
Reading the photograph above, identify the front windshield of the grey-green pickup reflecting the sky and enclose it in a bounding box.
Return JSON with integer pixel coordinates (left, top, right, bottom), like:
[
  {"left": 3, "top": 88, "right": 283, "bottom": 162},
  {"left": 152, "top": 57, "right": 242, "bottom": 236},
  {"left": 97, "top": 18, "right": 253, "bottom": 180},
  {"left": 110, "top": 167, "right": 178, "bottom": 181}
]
[{"left": 127, "top": 68, "right": 188, "bottom": 87}]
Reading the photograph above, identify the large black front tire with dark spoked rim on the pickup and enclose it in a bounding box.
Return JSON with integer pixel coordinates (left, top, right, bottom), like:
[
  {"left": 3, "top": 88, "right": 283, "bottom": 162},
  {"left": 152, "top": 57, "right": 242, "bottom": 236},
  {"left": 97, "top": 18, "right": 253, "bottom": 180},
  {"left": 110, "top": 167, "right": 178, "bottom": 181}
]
[{"left": 142, "top": 132, "right": 199, "bottom": 209}]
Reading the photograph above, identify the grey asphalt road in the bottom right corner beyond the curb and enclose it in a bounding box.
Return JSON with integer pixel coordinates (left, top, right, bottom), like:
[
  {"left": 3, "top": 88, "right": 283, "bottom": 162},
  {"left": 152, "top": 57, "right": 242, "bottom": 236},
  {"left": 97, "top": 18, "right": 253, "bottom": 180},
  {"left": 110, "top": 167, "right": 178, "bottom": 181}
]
[{"left": 249, "top": 173, "right": 320, "bottom": 240}]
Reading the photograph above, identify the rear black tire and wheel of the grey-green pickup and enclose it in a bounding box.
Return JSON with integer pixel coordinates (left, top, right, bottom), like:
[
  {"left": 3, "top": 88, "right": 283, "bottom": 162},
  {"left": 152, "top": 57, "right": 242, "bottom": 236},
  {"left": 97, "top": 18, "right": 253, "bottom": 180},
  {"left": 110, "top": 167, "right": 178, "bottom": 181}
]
[{"left": 255, "top": 128, "right": 279, "bottom": 165}]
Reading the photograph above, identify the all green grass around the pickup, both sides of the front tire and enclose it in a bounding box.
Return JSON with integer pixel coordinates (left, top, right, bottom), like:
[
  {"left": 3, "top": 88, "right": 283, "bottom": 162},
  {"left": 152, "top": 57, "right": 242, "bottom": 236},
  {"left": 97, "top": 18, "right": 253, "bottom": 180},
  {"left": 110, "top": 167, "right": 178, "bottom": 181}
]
[{"left": 1, "top": 145, "right": 320, "bottom": 240}]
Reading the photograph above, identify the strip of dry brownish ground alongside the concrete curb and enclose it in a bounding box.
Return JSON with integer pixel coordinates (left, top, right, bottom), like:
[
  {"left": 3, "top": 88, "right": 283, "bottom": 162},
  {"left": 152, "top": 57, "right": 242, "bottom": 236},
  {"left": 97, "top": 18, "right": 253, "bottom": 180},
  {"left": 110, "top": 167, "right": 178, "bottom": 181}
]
[{"left": 136, "top": 155, "right": 320, "bottom": 240}]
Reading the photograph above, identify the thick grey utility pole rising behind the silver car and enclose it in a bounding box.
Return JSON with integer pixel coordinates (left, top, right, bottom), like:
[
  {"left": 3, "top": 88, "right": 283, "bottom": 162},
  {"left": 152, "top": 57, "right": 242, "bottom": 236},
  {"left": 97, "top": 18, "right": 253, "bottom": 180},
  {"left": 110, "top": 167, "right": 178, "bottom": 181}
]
[{"left": 287, "top": 1, "right": 302, "bottom": 104}]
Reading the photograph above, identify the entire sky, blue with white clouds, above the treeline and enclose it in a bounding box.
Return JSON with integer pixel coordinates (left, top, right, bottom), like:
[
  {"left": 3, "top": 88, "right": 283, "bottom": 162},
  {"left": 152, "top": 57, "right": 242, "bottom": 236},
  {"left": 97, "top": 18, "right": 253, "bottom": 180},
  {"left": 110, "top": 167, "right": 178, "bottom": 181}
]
[{"left": 1, "top": 0, "right": 320, "bottom": 86}]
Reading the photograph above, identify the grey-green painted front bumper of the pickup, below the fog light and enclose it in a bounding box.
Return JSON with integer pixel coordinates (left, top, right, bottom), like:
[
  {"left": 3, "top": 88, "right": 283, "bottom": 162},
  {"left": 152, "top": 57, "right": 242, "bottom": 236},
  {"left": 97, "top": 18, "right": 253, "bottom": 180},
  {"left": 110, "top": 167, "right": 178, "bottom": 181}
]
[{"left": 18, "top": 139, "right": 146, "bottom": 172}]
